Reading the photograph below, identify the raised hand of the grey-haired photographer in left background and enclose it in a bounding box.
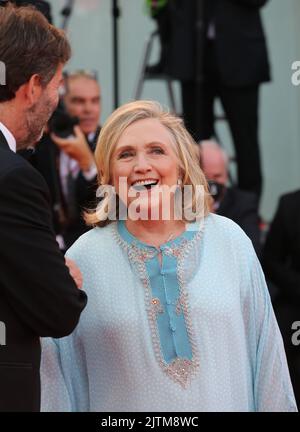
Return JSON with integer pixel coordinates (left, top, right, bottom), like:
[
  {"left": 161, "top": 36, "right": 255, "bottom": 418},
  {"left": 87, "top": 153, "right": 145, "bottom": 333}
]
[{"left": 51, "top": 125, "right": 94, "bottom": 171}]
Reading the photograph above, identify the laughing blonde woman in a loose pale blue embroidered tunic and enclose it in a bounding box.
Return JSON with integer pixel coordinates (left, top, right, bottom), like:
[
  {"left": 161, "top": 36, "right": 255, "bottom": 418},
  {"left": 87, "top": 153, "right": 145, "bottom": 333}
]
[{"left": 42, "top": 101, "right": 296, "bottom": 412}]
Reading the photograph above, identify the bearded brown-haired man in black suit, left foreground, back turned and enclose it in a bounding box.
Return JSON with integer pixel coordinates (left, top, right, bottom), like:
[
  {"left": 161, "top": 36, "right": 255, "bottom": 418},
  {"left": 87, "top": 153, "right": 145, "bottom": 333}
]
[{"left": 0, "top": 5, "right": 86, "bottom": 411}]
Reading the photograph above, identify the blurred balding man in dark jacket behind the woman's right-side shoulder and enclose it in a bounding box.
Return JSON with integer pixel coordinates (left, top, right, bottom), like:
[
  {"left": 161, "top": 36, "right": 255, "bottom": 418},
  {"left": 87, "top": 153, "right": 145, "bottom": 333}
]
[{"left": 200, "top": 141, "right": 261, "bottom": 256}]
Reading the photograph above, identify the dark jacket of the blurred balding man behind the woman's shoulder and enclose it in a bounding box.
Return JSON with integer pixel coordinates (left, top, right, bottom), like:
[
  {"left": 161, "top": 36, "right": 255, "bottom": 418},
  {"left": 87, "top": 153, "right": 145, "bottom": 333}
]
[{"left": 217, "top": 187, "right": 261, "bottom": 256}]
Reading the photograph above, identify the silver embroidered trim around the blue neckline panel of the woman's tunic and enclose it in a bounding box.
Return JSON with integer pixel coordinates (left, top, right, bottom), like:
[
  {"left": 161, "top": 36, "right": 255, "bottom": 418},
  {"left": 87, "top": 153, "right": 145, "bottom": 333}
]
[{"left": 112, "top": 220, "right": 204, "bottom": 388}]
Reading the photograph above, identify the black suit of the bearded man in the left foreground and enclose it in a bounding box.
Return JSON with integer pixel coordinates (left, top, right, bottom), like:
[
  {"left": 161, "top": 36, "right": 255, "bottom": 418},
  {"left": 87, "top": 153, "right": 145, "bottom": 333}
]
[{"left": 0, "top": 132, "right": 86, "bottom": 411}]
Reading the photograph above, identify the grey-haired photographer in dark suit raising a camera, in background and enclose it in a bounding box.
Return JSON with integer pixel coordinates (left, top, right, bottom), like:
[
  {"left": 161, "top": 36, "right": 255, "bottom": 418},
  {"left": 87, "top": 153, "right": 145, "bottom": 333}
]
[{"left": 32, "top": 71, "right": 101, "bottom": 250}]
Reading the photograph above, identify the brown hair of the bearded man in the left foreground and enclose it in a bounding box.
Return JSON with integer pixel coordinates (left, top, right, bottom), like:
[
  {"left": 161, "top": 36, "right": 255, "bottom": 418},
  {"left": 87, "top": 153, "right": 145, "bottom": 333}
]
[{"left": 0, "top": 4, "right": 71, "bottom": 102}]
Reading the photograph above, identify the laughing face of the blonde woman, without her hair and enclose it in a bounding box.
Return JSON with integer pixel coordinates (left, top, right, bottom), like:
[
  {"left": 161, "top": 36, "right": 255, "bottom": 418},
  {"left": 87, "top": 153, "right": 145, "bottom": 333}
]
[{"left": 111, "top": 118, "right": 179, "bottom": 219}]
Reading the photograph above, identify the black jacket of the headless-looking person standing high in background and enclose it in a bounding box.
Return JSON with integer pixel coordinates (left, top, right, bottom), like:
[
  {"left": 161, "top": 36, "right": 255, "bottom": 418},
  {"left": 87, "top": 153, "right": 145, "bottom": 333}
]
[{"left": 166, "top": 0, "right": 270, "bottom": 87}]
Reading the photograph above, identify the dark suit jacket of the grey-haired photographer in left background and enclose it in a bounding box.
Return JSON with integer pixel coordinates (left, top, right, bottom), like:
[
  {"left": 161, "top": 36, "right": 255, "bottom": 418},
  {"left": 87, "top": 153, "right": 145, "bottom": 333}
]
[{"left": 31, "top": 128, "right": 100, "bottom": 249}]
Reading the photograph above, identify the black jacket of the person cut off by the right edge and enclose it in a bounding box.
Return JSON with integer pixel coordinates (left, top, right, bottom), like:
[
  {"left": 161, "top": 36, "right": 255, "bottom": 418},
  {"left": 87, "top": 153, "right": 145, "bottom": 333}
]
[{"left": 263, "top": 190, "right": 300, "bottom": 306}]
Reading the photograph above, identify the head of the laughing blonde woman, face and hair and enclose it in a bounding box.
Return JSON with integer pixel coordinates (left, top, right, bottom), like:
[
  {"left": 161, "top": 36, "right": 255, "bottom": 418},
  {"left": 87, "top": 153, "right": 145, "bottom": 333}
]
[{"left": 86, "top": 101, "right": 210, "bottom": 231}]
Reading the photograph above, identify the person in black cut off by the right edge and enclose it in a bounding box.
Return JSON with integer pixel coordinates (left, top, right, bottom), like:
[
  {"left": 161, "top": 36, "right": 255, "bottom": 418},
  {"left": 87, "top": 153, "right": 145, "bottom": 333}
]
[{"left": 262, "top": 190, "right": 300, "bottom": 407}]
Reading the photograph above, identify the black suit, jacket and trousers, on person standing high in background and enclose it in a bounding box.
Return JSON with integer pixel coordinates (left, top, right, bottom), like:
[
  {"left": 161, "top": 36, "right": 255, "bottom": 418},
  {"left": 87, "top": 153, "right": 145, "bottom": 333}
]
[{"left": 165, "top": 0, "right": 270, "bottom": 195}]
